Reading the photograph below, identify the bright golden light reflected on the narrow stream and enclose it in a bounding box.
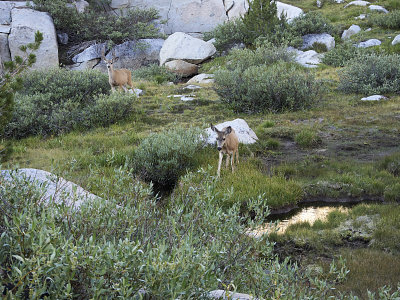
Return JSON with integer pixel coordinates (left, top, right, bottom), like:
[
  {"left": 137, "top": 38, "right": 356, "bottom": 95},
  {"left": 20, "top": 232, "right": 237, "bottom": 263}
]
[{"left": 248, "top": 206, "right": 348, "bottom": 237}]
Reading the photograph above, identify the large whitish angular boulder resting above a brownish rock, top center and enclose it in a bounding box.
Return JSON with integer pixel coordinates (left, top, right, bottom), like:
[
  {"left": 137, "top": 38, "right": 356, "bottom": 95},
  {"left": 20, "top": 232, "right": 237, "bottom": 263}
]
[{"left": 160, "top": 32, "right": 217, "bottom": 65}]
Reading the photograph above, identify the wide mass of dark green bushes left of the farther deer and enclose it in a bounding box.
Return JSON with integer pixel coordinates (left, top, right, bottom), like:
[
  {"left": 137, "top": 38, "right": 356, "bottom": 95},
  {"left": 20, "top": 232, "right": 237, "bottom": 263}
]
[{"left": 5, "top": 69, "right": 136, "bottom": 138}]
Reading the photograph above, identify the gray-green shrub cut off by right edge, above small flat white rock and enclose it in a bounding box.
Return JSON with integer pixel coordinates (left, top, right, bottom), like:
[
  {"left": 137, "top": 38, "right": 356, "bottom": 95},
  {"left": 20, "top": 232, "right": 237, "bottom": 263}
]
[{"left": 339, "top": 54, "right": 400, "bottom": 95}]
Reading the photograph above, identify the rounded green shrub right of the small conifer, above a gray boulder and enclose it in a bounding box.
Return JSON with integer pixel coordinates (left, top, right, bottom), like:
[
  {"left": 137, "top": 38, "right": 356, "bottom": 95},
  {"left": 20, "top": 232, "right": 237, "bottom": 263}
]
[{"left": 290, "top": 11, "right": 337, "bottom": 36}]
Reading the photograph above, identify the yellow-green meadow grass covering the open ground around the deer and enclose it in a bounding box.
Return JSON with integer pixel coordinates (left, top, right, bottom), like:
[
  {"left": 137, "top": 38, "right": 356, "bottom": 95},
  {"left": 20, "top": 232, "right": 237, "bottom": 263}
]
[{"left": 0, "top": 0, "right": 400, "bottom": 298}]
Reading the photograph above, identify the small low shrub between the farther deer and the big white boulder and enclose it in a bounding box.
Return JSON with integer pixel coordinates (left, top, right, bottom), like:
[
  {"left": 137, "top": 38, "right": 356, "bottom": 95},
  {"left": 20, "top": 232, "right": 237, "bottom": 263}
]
[{"left": 132, "top": 64, "right": 180, "bottom": 84}]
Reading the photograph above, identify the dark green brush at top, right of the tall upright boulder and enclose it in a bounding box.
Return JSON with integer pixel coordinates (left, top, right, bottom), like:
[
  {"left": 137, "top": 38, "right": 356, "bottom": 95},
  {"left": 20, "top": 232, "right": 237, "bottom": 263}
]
[{"left": 33, "top": 0, "right": 158, "bottom": 43}]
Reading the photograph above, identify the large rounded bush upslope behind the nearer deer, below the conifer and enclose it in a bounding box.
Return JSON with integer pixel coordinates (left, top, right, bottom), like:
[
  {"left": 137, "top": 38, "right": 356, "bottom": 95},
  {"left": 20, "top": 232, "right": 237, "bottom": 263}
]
[{"left": 215, "top": 46, "right": 320, "bottom": 113}]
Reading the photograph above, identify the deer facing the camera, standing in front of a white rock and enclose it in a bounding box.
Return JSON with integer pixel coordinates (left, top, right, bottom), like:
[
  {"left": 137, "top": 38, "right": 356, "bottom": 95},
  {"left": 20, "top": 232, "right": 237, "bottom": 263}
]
[{"left": 210, "top": 124, "right": 239, "bottom": 177}]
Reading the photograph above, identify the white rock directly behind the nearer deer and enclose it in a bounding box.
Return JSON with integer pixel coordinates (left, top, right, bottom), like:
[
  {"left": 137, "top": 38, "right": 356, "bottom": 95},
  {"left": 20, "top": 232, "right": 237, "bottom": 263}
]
[{"left": 206, "top": 119, "right": 258, "bottom": 145}]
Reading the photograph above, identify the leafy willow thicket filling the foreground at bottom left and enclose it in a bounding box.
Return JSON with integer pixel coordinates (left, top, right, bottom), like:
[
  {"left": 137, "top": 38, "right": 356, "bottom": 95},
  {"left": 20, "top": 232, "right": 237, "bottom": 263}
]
[{"left": 0, "top": 168, "right": 347, "bottom": 299}]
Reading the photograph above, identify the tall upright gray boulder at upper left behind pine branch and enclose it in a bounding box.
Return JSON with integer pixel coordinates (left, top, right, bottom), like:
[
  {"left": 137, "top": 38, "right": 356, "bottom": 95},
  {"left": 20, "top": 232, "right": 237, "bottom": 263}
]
[{"left": 8, "top": 8, "right": 58, "bottom": 69}]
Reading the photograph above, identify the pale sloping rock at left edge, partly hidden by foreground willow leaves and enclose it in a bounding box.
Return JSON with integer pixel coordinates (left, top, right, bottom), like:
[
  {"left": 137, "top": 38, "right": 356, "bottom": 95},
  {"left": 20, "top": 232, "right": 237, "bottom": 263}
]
[{"left": 0, "top": 169, "right": 101, "bottom": 209}]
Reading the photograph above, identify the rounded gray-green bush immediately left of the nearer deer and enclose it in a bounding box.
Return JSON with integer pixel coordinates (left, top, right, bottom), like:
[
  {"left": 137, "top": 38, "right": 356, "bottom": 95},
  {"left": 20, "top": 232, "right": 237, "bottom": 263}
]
[{"left": 133, "top": 128, "right": 203, "bottom": 189}]
